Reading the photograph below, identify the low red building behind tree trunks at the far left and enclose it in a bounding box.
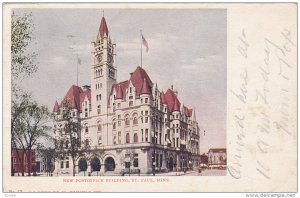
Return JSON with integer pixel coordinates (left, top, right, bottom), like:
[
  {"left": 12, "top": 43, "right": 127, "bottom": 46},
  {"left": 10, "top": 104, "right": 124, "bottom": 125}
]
[{"left": 11, "top": 149, "right": 36, "bottom": 173}]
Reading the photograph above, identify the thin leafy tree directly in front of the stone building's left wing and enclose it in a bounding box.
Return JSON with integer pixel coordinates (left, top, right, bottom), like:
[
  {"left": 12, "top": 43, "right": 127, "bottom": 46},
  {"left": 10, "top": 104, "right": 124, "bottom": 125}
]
[{"left": 54, "top": 100, "right": 90, "bottom": 176}]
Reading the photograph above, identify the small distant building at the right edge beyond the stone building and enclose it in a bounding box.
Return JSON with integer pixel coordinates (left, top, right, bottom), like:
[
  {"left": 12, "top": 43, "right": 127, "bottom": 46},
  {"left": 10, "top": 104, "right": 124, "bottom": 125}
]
[{"left": 208, "top": 148, "right": 227, "bottom": 166}]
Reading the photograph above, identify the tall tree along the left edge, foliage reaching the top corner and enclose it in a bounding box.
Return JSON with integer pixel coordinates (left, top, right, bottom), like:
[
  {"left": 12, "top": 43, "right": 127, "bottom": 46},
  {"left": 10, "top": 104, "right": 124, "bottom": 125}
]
[{"left": 11, "top": 12, "right": 37, "bottom": 176}]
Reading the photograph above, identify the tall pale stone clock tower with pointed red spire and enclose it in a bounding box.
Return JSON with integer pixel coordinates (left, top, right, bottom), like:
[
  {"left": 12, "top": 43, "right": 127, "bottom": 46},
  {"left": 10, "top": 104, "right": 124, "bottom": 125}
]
[{"left": 91, "top": 16, "right": 117, "bottom": 116}]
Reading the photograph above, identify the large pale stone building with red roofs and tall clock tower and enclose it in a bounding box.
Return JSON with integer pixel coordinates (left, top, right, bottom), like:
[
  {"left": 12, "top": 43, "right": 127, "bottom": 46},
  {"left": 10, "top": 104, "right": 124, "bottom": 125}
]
[{"left": 53, "top": 17, "right": 200, "bottom": 174}]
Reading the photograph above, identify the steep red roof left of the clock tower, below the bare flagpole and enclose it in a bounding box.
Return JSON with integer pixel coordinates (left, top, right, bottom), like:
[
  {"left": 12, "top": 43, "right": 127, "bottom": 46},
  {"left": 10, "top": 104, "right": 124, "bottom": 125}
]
[{"left": 60, "top": 85, "right": 91, "bottom": 110}]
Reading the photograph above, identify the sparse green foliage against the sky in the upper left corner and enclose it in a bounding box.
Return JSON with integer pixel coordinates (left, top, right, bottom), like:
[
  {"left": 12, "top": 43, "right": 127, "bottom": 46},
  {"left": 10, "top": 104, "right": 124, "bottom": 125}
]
[{"left": 11, "top": 12, "right": 38, "bottom": 81}]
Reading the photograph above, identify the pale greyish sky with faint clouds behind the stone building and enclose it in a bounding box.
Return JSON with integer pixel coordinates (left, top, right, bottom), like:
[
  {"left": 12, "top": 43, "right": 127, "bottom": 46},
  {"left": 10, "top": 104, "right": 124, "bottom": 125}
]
[{"left": 16, "top": 8, "right": 227, "bottom": 153}]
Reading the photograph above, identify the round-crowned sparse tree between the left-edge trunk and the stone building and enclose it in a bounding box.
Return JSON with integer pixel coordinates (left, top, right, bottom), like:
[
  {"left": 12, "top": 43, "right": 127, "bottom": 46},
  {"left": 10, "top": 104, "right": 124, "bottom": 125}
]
[{"left": 12, "top": 100, "right": 50, "bottom": 176}]
